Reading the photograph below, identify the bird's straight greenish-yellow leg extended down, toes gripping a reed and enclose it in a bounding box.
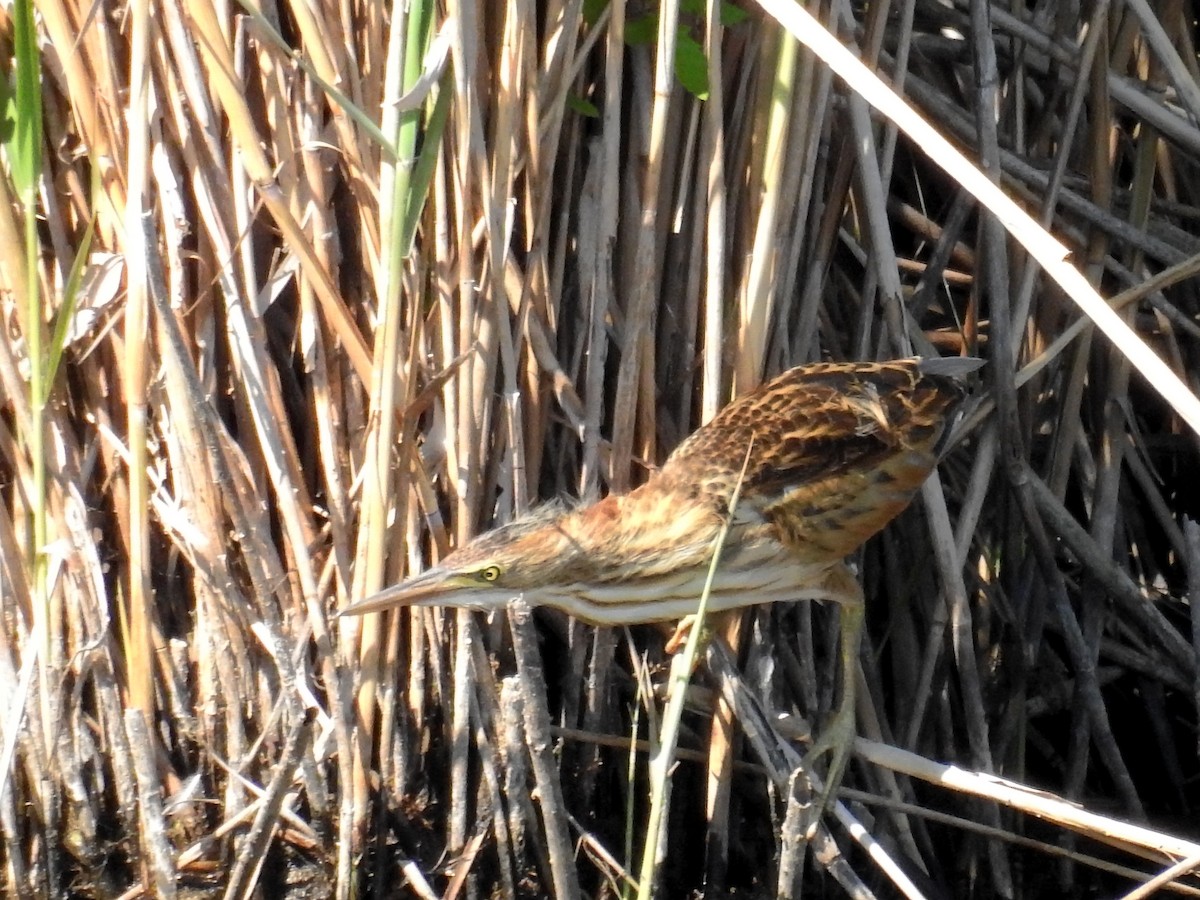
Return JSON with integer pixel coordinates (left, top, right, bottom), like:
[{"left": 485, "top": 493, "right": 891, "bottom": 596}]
[{"left": 804, "top": 565, "right": 864, "bottom": 834}]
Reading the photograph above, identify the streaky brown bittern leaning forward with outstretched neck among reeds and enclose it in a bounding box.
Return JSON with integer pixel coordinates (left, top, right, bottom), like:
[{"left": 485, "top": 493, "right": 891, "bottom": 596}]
[{"left": 342, "top": 358, "right": 983, "bottom": 820}]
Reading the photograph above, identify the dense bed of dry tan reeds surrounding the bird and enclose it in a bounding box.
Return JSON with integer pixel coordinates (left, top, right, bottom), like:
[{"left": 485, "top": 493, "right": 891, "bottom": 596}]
[{"left": 0, "top": 0, "right": 1200, "bottom": 898}]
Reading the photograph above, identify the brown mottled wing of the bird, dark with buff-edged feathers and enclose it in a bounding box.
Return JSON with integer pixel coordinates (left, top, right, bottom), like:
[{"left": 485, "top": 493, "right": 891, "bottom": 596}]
[{"left": 661, "top": 359, "right": 979, "bottom": 560}]
